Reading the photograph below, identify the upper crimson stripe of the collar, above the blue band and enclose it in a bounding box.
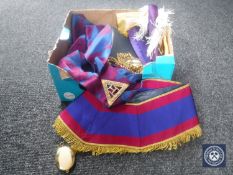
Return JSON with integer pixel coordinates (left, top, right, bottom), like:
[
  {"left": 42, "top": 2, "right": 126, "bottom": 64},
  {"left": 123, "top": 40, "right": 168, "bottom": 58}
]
[{"left": 83, "top": 86, "right": 191, "bottom": 114}]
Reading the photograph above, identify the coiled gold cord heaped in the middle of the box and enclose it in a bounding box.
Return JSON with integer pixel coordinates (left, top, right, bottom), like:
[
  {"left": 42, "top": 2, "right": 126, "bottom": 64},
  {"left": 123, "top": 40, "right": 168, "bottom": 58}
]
[{"left": 108, "top": 53, "right": 143, "bottom": 73}]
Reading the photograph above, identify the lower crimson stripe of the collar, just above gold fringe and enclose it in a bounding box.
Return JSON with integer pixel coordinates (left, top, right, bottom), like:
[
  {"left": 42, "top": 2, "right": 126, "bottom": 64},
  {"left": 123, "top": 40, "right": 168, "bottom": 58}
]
[{"left": 61, "top": 111, "right": 199, "bottom": 147}]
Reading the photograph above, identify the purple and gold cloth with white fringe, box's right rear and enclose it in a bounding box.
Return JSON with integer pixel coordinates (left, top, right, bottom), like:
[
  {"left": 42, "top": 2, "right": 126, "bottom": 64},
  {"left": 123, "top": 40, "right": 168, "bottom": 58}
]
[{"left": 117, "top": 4, "right": 173, "bottom": 64}]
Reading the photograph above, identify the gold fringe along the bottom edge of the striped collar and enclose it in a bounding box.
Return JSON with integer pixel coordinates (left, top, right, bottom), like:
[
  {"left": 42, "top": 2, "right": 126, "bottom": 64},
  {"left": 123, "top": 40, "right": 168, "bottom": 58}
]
[{"left": 53, "top": 116, "right": 202, "bottom": 155}]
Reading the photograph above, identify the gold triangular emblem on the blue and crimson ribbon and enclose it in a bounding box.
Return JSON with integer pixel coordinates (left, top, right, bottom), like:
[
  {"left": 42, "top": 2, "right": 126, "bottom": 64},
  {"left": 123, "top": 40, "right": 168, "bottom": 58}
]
[{"left": 101, "top": 80, "right": 129, "bottom": 107}]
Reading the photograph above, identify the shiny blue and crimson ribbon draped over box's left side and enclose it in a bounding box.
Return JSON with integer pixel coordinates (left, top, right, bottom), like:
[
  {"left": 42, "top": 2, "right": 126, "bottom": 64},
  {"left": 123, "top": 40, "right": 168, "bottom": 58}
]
[{"left": 58, "top": 15, "right": 142, "bottom": 107}]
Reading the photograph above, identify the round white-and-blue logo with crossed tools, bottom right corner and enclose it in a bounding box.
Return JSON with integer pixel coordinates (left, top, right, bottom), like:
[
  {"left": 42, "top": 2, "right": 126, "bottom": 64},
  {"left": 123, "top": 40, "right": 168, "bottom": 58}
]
[{"left": 204, "top": 146, "right": 225, "bottom": 166}]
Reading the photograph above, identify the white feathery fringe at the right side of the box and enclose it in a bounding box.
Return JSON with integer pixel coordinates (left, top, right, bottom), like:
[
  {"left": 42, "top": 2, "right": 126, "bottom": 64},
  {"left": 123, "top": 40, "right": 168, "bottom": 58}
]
[{"left": 146, "top": 7, "right": 174, "bottom": 59}]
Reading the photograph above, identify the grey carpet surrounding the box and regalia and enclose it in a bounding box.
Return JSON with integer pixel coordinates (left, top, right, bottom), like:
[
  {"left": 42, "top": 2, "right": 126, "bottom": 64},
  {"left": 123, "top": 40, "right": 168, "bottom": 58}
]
[{"left": 0, "top": 0, "right": 233, "bottom": 175}]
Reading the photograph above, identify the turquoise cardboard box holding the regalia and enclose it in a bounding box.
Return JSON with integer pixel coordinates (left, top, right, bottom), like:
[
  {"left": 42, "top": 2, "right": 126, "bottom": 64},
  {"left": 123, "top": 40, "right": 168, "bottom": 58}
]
[{"left": 48, "top": 10, "right": 173, "bottom": 101}]
